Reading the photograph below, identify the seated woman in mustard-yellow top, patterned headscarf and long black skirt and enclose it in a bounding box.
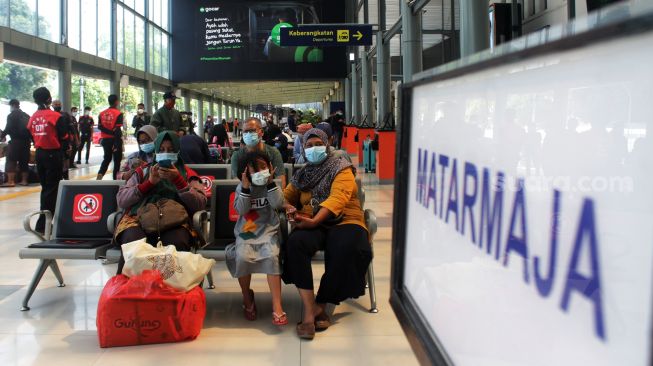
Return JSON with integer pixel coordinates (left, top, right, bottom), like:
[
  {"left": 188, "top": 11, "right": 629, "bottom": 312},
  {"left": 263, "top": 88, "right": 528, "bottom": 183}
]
[{"left": 282, "top": 128, "right": 372, "bottom": 339}]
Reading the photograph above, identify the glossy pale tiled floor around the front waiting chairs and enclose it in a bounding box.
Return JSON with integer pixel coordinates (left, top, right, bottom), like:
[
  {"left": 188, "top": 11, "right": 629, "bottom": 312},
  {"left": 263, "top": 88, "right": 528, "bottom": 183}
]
[{"left": 0, "top": 149, "right": 417, "bottom": 366}]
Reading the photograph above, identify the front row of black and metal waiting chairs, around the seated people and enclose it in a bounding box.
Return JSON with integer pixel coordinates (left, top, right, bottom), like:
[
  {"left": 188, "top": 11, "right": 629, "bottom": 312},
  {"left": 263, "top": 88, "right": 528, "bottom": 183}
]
[{"left": 19, "top": 165, "right": 378, "bottom": 313}]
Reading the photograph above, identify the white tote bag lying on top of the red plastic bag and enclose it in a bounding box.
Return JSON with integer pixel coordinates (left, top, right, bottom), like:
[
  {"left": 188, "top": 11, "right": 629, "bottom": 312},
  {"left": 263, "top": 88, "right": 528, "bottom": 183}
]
[{"left": 122, "top": 239, "right": 215, "bottom": 292}]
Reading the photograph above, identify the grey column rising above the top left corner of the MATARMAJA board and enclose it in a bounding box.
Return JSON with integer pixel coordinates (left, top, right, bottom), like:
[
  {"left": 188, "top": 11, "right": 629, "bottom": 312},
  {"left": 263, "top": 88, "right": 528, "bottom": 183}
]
[{"left": 400, "top": 0, "right": 422, "bottom": 82}]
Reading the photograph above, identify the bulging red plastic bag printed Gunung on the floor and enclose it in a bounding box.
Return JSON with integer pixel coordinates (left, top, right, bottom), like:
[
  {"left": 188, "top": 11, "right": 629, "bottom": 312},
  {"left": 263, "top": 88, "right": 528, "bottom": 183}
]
[{"left": 97, "top": 270, "right": 206, "bottom": 348}]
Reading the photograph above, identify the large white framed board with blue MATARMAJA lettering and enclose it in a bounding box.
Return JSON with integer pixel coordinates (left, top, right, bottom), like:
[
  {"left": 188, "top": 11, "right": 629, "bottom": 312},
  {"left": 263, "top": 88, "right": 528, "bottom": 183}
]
[{"left": 391, "top": 3, "right": 653, "bottom": 366}]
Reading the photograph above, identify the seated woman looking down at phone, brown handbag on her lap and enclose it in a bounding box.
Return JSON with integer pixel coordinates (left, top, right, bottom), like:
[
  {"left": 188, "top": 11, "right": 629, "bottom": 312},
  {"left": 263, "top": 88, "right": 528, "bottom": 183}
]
[{"left": 115, "top": 131, "right": 206, "bottom": 273}]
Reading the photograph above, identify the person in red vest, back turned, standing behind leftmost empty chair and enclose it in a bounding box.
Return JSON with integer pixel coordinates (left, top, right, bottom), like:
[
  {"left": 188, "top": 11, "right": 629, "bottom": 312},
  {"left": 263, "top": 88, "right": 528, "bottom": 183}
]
[{"left": 27, "top": 87, "right": 67, "bottom": 233}]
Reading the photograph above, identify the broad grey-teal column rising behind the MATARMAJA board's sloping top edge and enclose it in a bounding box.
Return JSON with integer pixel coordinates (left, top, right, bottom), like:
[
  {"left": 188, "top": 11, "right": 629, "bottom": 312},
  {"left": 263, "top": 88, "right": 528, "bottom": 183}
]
[{"left": 460, "top": 0, "right": 490, "bottom": 57}]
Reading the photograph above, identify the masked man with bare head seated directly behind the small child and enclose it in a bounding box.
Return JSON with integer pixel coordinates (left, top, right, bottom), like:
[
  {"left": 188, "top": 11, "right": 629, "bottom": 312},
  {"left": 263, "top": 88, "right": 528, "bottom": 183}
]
[{"left": 231, "top": 117, "right": 286, "bottom": 187}]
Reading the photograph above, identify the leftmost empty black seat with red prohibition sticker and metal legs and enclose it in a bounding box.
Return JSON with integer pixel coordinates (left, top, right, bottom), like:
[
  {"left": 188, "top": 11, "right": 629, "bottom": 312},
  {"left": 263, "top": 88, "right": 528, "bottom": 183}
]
[{"left": 18, "top": 181, "right": 124, "bottom": 311}]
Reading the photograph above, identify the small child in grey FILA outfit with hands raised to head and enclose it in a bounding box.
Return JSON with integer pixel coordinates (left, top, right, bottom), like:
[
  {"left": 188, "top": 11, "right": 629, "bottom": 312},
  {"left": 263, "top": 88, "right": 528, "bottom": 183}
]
[{"left": 225, "top": 151, "right": 288, "bottom": 325}]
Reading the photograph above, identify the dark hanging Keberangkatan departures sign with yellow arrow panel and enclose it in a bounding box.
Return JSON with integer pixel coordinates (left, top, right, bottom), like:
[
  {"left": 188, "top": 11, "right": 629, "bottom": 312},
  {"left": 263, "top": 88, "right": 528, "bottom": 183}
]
[{"left": 280, "top": 24, "right": 372, "bottom": 47}]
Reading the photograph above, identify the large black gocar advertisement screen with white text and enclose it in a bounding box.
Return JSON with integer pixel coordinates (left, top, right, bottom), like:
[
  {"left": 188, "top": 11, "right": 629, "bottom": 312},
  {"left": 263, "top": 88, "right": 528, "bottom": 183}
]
[{"left": 172, "top": 0, "right": 347, "bottom": 82}]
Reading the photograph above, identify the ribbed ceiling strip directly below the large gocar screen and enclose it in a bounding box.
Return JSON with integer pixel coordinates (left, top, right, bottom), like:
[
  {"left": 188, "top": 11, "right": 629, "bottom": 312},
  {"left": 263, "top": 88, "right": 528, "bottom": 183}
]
[{"left": 179, "top": 81, "right": 342, "bottom": 105}]
